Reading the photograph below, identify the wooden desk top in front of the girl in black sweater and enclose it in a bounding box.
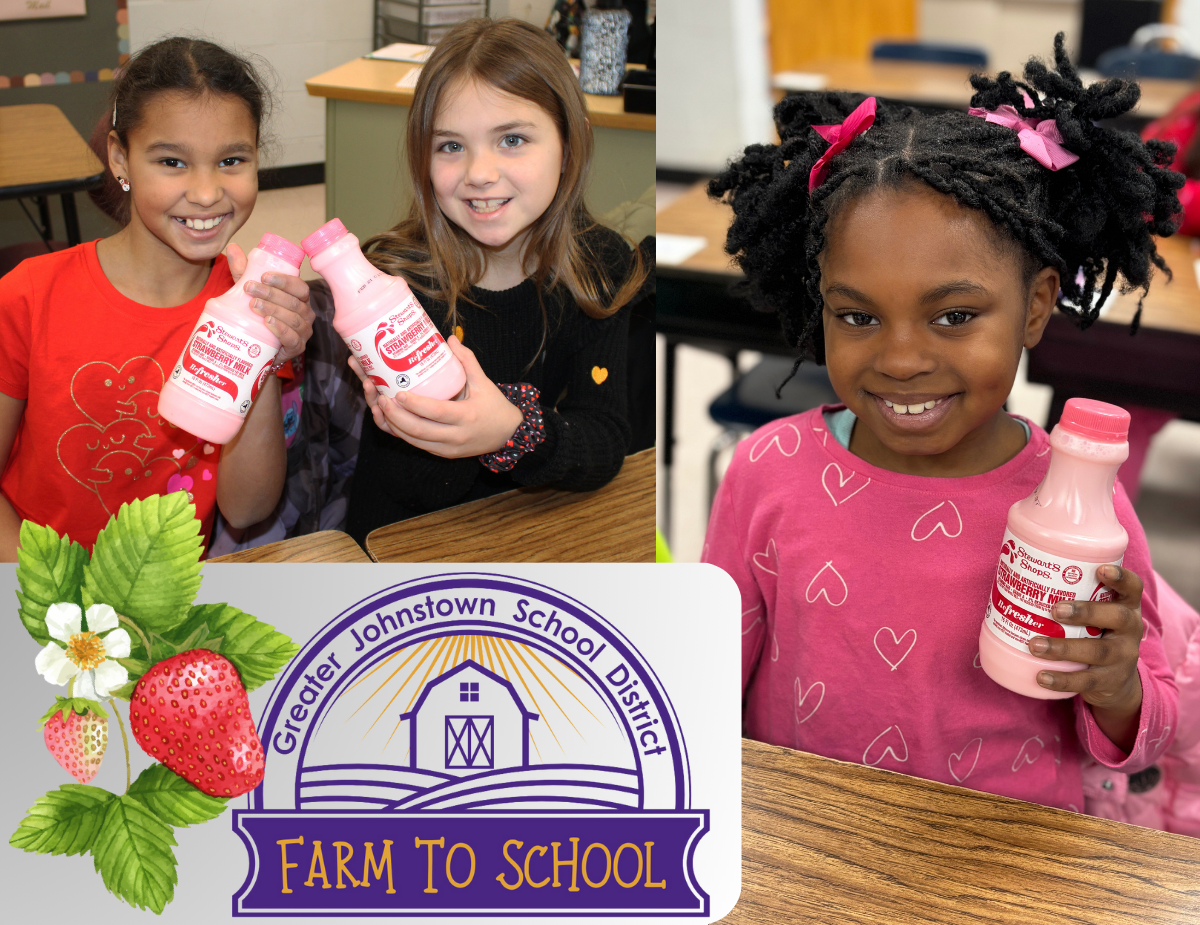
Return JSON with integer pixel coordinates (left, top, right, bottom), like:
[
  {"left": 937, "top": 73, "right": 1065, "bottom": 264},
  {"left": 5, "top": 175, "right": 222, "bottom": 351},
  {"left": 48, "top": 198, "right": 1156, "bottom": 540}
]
[{"left": 367, "top": 449, "right": 654, "bottom": 561}]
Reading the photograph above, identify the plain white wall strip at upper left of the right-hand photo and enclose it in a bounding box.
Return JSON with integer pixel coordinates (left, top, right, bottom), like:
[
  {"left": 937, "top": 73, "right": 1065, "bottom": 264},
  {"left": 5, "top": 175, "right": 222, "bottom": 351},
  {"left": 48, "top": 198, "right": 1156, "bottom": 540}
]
[{"left": 656, "top": 0, "right": 773, "bottom": 172}]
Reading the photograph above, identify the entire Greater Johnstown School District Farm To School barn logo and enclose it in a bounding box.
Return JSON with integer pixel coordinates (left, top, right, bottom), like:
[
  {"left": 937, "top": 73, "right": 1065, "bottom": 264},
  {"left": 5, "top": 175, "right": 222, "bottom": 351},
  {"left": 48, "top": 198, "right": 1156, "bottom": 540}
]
[{"left": 233, "top": 573, "right": 708, "bottom": 918}]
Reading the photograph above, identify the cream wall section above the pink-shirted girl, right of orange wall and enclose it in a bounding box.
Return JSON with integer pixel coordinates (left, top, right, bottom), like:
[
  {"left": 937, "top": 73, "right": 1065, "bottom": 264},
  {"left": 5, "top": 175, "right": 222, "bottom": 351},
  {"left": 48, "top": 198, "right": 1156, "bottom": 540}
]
[{"left": 917, "top": 0, "right": 1084, "bottom": 72}]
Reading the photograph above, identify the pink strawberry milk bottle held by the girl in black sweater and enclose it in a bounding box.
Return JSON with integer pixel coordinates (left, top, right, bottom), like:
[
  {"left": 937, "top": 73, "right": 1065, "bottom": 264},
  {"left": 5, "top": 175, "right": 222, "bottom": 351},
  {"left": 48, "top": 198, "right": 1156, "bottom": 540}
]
[{"left": 300, "top": 218, "right": 467, "bottom": 400}]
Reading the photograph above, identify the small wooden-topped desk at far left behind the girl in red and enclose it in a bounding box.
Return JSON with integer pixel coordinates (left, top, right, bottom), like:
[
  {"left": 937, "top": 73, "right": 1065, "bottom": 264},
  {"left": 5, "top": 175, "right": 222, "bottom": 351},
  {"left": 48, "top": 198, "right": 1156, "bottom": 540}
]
[{"left": 0, "top": 103, "right": 104, "bottom": 246}]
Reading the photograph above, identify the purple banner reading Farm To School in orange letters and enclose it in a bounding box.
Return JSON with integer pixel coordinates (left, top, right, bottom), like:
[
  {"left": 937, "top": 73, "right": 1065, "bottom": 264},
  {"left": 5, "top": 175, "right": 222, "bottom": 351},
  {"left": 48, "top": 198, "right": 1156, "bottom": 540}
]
[{"left": 233, "top": 810, "right": 708, "bottom": 917}]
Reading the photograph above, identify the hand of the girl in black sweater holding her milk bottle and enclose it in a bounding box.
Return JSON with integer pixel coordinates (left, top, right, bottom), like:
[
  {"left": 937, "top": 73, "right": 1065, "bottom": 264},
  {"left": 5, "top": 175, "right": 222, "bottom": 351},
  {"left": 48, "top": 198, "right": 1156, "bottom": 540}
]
[{"left": 349, "top": 335, "right": 523, "bottom": 460}]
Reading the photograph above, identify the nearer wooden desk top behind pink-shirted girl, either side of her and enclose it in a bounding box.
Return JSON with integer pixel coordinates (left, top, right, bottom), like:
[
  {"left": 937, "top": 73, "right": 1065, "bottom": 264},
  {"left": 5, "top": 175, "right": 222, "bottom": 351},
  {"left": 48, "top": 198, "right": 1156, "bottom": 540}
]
[{"left": 656, "top": 182, "right": 1200, "bottom": 335}]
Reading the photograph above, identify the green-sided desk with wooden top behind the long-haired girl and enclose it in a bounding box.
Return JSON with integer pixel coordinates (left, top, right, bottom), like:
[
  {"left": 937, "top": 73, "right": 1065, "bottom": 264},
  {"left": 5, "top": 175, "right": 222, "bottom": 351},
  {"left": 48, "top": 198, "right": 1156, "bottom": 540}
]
[{"left": 305, "top": 58, "right": 655, "bottom": 240}]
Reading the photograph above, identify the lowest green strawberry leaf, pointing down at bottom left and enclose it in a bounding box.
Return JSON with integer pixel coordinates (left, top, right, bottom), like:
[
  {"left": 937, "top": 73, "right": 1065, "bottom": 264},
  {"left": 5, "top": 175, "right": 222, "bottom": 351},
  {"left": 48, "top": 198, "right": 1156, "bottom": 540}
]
[{"left": 91, "top": 794, "right": 178, "bottom": 913}]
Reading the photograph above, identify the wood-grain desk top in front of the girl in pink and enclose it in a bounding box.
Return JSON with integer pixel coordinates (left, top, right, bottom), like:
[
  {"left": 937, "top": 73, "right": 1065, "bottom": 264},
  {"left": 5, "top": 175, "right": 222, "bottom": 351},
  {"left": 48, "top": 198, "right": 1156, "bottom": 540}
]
[{"left": 724, "top": 740, "right": 1200, "bottom": 925}]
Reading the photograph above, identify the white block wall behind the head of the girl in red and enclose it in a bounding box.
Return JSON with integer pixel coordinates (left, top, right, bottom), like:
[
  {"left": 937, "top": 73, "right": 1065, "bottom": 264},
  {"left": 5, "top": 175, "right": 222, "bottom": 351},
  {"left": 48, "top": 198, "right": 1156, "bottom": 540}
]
[{"left": 128, "top": 0, "right": 374, "bottom": 167}]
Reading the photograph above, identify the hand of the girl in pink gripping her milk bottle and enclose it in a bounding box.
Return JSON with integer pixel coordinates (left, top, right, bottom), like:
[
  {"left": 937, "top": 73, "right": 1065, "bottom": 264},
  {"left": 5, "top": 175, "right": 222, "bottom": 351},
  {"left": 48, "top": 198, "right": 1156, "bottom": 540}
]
[{"left": 1030, "top": 565, "right": 1144, "bottom": 752}]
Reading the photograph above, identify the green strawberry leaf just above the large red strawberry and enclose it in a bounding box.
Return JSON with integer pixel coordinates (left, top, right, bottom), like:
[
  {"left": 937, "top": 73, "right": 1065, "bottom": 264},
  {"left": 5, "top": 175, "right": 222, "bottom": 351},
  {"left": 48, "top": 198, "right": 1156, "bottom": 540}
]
[{"left": 162, "top": 603, "right": 300, "bottom": 691}]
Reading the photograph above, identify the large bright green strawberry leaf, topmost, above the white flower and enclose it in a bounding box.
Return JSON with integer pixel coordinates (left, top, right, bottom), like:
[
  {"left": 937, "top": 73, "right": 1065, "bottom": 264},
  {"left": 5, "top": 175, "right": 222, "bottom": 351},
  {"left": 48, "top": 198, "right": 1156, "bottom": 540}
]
[{"left": 84, "top": 492, "right": 200, "bottom": 638}]
